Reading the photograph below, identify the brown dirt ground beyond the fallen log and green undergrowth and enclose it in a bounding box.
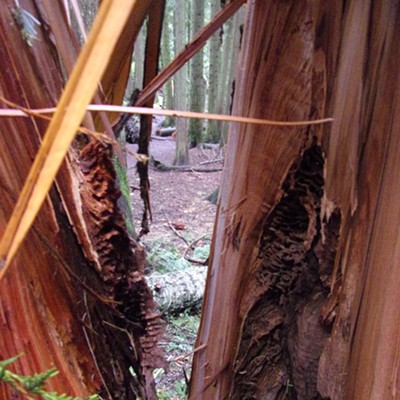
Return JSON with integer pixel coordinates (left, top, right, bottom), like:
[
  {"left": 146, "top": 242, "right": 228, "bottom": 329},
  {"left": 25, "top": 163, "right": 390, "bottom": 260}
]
[{"left": 127, "top": 137, "right": 222, "bottom": 251}]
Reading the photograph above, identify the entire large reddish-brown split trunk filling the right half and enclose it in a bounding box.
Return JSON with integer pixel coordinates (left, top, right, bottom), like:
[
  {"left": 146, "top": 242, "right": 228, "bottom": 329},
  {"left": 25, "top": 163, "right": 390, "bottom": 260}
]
[{"left": 190, "top": 0, "right": 400, "bottom": 400}]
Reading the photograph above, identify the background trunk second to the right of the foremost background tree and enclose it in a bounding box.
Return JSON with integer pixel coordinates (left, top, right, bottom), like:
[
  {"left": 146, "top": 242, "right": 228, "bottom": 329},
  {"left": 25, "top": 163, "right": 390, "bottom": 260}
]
[{"left": 206, "top": 1, "right": 223, "bottom": 143}]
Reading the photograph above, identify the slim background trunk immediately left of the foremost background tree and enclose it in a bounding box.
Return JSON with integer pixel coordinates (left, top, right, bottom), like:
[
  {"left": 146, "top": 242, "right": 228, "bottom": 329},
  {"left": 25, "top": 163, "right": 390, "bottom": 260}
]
[{"left": 161, "top": 1, "right": 175, "bottom": 126}]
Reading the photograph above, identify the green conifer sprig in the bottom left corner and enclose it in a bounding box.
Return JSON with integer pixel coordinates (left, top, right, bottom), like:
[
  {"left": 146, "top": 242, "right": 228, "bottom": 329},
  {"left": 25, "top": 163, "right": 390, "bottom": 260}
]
[{"left": 0, "top": 355, "right": 99, "bottom": 400}]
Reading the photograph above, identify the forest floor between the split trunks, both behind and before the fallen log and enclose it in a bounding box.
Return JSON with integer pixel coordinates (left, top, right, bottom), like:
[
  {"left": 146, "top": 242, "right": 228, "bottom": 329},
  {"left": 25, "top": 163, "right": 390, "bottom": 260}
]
[{"left": 127, "top": 133, "right": 222, "bottom": 400}]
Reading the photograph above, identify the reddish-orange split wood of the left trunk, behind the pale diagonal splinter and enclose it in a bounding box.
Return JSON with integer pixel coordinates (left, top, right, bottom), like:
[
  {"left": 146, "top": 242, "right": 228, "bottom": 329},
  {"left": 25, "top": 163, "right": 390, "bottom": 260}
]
[{"left": 0, "top": 1, "right": 101, "bottom": 400}]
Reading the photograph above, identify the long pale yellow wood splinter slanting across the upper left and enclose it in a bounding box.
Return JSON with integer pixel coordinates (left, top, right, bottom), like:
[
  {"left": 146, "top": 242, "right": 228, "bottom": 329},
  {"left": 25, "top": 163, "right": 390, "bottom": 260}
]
[{"left": 0, "top": 1, "right": 141, "bottom": 278}]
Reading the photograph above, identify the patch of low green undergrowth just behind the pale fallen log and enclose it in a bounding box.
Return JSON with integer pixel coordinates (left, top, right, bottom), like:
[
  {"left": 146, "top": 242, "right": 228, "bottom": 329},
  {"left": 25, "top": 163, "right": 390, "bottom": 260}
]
[{"left": 147, "top": 241, "right": 190, "bottom": 273}]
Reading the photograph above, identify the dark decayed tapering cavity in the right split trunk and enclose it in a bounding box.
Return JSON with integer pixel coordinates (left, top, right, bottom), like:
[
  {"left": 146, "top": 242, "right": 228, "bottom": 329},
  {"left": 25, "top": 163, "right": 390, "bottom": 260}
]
[{"left": 230, "top": 143, "right": 340, "bottom": 400}]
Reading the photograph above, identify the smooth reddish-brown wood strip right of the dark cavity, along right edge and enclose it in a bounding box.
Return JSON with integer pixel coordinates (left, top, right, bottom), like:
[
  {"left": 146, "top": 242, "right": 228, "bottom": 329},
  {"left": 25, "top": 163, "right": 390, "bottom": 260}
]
[{"left": 320, "top": 0, "right": 400, "bottom": 400}]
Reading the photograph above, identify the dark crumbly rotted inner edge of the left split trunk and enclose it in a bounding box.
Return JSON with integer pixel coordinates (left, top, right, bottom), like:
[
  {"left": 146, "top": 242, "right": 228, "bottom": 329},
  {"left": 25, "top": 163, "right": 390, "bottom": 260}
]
[{"left": 80, "top": 141, "right": 165, "bottom": 399}]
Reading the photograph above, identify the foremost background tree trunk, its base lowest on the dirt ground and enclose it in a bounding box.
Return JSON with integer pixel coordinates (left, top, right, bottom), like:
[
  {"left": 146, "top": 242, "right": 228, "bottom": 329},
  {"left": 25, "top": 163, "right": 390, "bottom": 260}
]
[{"left": 174, "top": 0, "right": 189, "bottom": 165}]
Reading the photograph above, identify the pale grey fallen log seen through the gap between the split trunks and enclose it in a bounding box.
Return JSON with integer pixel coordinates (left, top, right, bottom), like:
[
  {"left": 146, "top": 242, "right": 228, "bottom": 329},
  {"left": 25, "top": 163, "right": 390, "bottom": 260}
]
[{"left": 147, "top": 267, "right": 207, "bottom": 314}]
